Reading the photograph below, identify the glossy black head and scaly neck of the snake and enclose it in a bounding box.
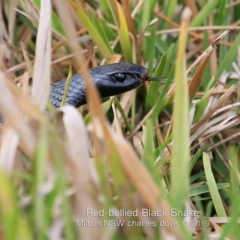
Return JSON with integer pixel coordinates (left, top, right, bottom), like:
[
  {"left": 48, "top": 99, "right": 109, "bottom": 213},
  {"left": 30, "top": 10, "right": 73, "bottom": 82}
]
[{"left": 50, "top": 62, "right": 148, "bottom": 108}]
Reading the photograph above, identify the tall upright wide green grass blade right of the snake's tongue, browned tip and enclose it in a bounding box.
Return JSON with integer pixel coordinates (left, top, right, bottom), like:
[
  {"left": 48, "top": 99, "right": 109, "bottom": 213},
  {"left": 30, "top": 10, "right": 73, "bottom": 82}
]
[{"left": 170, "top": 13, "right": 190, "bottom": 209}]
